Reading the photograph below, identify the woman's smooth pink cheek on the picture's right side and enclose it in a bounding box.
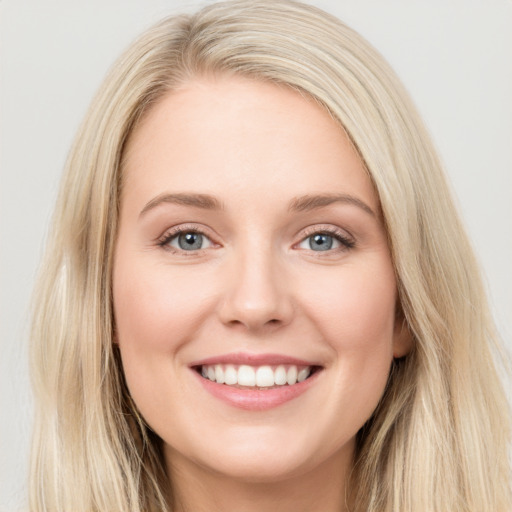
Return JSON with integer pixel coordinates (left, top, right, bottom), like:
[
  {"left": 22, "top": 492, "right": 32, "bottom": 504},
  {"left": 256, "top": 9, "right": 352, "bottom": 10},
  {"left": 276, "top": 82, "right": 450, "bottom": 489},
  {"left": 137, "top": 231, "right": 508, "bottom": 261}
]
[{"left": 296, "top": 265, "right": 396, "bottom": 406}]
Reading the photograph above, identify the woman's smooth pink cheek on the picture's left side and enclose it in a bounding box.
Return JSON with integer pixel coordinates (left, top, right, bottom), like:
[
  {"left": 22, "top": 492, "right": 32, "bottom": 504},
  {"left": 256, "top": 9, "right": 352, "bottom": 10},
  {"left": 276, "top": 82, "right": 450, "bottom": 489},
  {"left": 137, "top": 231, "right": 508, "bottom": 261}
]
[{"left": 113, "top": 256, "right": 212, "bottom": 414}]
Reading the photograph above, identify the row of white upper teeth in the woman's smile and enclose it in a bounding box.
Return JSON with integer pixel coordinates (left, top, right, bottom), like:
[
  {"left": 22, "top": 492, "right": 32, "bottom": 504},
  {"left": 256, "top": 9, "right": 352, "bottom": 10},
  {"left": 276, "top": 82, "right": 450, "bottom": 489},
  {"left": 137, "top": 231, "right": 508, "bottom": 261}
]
[{"left": 201, "top": 364, "right": 311, "bottom": 388}]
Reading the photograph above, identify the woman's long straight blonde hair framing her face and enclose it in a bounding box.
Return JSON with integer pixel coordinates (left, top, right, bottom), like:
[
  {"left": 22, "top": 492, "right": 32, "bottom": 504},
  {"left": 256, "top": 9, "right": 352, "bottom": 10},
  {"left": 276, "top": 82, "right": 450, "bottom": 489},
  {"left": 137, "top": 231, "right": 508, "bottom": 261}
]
[{"left": 30, "top": 0, "right": 512, "bottom": 512}]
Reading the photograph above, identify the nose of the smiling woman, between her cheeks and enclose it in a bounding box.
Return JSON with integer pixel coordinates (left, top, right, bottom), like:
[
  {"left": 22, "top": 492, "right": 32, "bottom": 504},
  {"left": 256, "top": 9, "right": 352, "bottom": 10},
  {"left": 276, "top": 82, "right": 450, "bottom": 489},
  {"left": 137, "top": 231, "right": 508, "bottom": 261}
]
[{"left": 219, "top": 245, "right": 294, "bottom": 332}]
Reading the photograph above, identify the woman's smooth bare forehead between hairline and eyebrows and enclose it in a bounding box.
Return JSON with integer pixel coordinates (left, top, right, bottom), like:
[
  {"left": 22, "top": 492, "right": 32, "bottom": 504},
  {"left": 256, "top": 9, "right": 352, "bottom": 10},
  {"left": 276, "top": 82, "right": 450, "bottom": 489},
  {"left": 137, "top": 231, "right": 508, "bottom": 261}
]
[{"left": 123, "top": 76, "right": 377, "bottom": 212}]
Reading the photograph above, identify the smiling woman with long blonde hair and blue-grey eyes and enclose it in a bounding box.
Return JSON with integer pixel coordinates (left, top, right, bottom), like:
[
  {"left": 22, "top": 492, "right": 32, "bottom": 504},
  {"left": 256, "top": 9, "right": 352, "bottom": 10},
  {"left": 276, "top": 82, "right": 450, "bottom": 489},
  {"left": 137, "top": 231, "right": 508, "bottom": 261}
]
[{"left": 31, "top": 1, "right": 511, "bottom": 512}]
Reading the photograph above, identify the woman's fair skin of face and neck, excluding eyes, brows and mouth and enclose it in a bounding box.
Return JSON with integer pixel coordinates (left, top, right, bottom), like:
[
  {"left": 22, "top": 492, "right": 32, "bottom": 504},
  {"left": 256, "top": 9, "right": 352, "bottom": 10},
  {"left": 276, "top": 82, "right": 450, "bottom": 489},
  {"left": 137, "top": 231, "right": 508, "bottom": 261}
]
[{"left": 113, "top": 76, "right": 410, "bottom": 512}]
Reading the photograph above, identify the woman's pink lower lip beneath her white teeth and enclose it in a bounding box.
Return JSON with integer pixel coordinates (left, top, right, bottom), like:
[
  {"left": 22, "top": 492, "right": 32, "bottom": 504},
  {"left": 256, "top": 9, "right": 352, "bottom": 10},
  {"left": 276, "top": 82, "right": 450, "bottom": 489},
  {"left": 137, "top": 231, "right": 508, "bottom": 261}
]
[{"left": 192, "top": 370, "right": 321, "bottom": 411}]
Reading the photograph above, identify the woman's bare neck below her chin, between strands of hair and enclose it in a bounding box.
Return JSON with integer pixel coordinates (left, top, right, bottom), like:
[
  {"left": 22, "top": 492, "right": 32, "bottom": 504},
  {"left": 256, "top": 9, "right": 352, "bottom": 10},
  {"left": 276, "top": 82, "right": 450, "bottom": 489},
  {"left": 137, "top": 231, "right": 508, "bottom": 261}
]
[{"left": 166, "top": 444, "right": 352, "bottom": 512}]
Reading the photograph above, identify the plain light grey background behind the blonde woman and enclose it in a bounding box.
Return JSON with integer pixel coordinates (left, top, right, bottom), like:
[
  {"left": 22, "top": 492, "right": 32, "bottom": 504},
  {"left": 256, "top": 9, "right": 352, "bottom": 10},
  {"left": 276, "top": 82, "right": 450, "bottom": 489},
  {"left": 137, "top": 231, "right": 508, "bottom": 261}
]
[{"left": 0, "top": 0, "right": 512, "bottom": 512}]
